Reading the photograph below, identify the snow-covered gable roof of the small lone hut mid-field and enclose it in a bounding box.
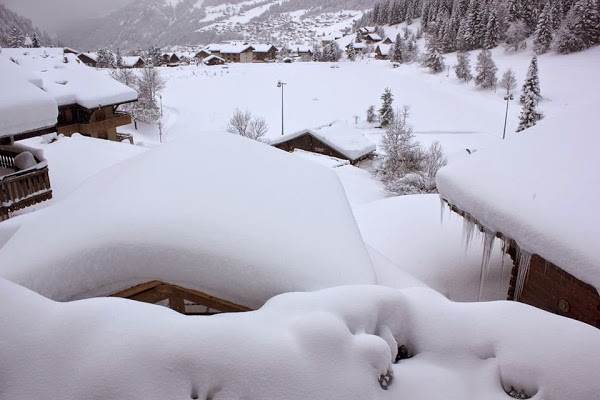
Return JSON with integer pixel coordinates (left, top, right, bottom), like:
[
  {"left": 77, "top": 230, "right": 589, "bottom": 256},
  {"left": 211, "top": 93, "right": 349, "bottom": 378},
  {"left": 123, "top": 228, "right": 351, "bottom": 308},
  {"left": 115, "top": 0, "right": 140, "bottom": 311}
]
[{"left": 269, "top": 121, "right": 376, "bottom": 161}]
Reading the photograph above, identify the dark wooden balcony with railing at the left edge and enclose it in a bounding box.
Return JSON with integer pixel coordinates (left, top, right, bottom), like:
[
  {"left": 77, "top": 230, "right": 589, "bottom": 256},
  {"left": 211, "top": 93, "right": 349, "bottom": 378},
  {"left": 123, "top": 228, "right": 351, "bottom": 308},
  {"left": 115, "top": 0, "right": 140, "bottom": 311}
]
[{"left": 0, "top": 146, "right": 52, "bottom": 221}]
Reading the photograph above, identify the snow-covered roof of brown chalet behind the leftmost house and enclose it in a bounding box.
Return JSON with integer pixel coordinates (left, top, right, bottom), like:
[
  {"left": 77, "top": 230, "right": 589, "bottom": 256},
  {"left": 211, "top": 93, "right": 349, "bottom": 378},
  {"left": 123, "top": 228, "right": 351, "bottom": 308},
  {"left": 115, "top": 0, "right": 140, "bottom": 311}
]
[{"left": 0, "top": 49, "right": 137, "bottom": 109}]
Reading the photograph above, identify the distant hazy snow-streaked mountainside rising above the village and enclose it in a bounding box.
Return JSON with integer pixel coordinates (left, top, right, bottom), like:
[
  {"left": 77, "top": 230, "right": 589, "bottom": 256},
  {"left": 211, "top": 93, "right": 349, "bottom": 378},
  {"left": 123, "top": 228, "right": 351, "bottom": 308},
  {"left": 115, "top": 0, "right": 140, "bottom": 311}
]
[{"left": 59, "top": 0, "right": 372, "bottom": 51}]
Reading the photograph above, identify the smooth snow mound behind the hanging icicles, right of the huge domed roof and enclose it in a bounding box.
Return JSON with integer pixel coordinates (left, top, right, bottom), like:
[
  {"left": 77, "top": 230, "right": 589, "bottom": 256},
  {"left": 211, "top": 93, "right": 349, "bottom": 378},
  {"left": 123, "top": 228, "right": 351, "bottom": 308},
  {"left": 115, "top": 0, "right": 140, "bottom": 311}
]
[{"left": 354, "top": 195, "right": 510, "bottom": 301}]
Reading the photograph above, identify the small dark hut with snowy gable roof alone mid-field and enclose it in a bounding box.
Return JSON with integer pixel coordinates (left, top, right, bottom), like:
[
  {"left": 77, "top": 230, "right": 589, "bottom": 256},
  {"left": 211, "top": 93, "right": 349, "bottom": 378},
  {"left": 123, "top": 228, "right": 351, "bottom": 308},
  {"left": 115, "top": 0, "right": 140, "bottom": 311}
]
[{"left": 269, "top": 121, "right": 376, "bottom": 165}]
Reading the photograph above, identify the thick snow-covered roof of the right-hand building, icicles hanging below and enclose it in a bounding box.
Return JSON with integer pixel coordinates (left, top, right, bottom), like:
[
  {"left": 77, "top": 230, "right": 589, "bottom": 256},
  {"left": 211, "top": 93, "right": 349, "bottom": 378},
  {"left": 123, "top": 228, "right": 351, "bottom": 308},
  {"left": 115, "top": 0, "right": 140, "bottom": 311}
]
[{"left": 437, "top": 127, "right": 600, "bottom": 288}]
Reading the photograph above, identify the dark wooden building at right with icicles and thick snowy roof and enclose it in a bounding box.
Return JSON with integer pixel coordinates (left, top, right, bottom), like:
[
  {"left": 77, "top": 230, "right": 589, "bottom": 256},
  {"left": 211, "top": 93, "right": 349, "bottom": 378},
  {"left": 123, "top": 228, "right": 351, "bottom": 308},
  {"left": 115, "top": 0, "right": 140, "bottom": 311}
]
[{"left": 437, "top": 127, "right": 600, "bottom": 328}]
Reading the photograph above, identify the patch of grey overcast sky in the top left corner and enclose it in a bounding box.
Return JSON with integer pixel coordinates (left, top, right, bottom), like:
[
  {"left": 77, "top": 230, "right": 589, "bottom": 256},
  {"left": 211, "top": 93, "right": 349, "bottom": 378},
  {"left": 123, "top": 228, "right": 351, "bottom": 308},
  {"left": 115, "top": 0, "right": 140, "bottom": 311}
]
[{"left": 0, "top": 0, "right": 134, "bottom": 33}]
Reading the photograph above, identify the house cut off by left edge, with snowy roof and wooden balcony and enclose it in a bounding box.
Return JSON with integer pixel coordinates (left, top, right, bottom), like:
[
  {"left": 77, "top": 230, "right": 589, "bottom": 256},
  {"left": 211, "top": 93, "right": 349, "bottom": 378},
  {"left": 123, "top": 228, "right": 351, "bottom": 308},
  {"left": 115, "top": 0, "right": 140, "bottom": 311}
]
[{"left": 0, "top": 56, "right": 57, "bottom": 221}]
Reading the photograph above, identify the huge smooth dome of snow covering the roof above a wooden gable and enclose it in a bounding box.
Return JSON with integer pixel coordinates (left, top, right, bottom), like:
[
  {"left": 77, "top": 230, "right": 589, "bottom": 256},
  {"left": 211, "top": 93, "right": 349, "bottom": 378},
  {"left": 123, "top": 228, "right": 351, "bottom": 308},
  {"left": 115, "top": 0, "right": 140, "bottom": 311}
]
[{"left": 0, "top": 134, "right": 375, "bottom": 307}]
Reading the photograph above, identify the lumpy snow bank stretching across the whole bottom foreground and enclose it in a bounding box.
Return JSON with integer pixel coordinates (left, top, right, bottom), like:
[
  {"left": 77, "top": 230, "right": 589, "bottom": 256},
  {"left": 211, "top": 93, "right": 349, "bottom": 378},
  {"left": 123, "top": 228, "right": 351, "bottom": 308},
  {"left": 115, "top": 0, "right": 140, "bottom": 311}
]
[{"left": 0, "top": 280, "right": 600, "bottom": 400}]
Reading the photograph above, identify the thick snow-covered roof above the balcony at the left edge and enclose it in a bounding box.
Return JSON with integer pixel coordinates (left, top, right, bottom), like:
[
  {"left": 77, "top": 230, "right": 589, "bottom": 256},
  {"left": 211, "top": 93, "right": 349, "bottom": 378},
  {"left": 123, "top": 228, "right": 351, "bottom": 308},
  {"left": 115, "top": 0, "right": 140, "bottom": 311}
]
[{"left": 0, "top": 56, "right": 58, "bottom": 137}]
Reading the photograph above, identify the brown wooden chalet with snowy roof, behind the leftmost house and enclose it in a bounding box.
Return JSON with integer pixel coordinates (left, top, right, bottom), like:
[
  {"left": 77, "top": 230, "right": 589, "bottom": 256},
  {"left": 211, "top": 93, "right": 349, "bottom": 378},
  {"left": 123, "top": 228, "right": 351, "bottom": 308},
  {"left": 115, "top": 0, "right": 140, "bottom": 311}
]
[{"left": 2, "top": 49, "right": 137, "bottom": 145}]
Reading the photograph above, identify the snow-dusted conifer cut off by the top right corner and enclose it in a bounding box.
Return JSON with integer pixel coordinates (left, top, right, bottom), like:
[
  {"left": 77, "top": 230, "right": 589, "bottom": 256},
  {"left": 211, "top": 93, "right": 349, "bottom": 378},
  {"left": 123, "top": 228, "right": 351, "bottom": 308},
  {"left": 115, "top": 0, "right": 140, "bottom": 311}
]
[{"left": 554, "top": 0, "right": 600, "bottom": 54}]
